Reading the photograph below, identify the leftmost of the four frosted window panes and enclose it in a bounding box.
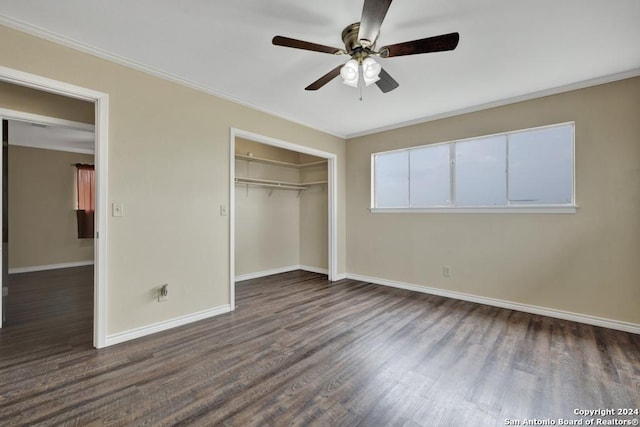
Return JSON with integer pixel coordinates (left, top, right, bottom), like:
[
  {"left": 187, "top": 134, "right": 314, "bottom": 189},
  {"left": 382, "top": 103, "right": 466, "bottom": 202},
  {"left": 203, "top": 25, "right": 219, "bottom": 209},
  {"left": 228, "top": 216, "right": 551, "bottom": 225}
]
[{"left": 374, "top": 151, "right": 409, "bottom": 208}]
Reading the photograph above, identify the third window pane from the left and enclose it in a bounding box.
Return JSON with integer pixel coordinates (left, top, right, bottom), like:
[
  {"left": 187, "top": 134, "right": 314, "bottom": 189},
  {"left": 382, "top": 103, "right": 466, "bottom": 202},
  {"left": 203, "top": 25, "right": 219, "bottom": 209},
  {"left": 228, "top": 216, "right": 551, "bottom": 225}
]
[{"left": 455, "top": 136, "right": 507, "bottom": 206}]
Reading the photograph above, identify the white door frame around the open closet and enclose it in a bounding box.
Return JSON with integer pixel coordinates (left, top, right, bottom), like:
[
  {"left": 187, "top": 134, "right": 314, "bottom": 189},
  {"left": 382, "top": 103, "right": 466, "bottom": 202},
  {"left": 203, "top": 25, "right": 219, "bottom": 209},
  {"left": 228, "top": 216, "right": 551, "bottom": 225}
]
[{"left": 229, "top": 128, "right": 339, "bottom": 310}]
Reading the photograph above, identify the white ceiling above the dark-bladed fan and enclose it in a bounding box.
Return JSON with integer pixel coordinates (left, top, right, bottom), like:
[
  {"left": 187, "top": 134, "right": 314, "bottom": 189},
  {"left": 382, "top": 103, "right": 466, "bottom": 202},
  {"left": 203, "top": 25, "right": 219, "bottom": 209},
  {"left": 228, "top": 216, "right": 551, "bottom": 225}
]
[{"left": 0, "top": 0, "right": 640, "bottom": 137}]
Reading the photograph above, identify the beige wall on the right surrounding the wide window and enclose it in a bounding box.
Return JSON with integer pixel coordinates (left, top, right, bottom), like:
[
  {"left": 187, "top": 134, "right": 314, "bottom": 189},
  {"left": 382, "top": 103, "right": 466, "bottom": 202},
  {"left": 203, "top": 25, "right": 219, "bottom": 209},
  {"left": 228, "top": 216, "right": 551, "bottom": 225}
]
[{"left": 347, "top": 78, "right": 640, "bottom": 324}]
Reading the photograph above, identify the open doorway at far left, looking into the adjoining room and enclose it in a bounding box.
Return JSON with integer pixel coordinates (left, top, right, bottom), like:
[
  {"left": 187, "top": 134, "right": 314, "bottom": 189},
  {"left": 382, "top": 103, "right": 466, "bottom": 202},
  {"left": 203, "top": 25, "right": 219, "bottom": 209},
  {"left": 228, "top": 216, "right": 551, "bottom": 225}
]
[{"left": 3, "top": 118, "right": 95, "bottom": 334}]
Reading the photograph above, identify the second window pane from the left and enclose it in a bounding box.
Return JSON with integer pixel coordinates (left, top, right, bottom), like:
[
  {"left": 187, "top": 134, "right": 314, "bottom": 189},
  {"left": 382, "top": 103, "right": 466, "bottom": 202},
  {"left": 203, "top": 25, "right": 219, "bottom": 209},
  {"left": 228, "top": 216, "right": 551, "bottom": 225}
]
[{"left": 409, "top": 144, "right": 451, "bottom": 207}]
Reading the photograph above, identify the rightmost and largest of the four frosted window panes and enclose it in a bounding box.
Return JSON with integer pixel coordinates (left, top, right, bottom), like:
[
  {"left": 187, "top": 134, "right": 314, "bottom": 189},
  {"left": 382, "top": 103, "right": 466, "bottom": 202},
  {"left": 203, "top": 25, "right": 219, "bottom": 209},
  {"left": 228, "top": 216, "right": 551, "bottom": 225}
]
[{"left": 509, "top": 126, "right": 573, "bottom": 205}]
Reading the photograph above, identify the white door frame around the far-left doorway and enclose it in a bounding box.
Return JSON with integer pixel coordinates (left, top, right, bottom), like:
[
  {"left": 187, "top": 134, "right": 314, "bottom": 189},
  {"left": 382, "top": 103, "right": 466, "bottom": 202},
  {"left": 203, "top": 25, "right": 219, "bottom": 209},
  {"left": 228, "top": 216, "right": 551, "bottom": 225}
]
[{"left": 0, "top": 66, "right": 109, "bottom": 348}]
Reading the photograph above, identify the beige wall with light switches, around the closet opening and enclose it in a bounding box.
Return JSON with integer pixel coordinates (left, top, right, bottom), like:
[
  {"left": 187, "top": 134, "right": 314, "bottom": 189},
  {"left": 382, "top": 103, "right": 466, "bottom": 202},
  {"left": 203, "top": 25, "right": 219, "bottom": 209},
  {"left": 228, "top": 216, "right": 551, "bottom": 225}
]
[{"left": 0, "top": 26, "right": 346, "bottom": 335}]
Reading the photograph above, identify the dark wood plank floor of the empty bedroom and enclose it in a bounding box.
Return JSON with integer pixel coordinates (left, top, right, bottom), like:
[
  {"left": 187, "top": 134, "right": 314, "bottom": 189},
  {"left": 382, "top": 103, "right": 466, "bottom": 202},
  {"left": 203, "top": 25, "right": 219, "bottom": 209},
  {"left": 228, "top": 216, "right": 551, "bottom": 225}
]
[{"left": 0, "top": 272, "right": 640, "bottom": 426}]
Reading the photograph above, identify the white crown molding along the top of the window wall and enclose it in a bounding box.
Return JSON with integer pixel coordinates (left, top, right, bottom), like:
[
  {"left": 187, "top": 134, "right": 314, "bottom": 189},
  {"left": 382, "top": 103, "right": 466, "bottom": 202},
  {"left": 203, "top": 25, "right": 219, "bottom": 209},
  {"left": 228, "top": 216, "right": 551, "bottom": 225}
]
[{"left": 343, "top": 68, "right": 640, "bottom": 139}]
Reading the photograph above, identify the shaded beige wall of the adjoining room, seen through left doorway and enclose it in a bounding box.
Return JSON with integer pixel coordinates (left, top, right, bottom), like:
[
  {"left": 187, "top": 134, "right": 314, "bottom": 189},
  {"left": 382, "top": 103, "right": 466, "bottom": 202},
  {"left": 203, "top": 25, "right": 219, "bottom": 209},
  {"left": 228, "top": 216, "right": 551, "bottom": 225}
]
[{"left": 8, "top": 145, "right": 93, "bottom": 269}]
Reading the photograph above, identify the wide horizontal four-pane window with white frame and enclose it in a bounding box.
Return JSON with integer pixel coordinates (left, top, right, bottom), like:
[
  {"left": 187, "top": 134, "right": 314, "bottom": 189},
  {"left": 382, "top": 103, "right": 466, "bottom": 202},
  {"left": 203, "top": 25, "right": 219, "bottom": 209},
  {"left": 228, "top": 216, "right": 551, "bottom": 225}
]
[{"left": 371, "top": 123, "right": 575, "bottom": 212}]
